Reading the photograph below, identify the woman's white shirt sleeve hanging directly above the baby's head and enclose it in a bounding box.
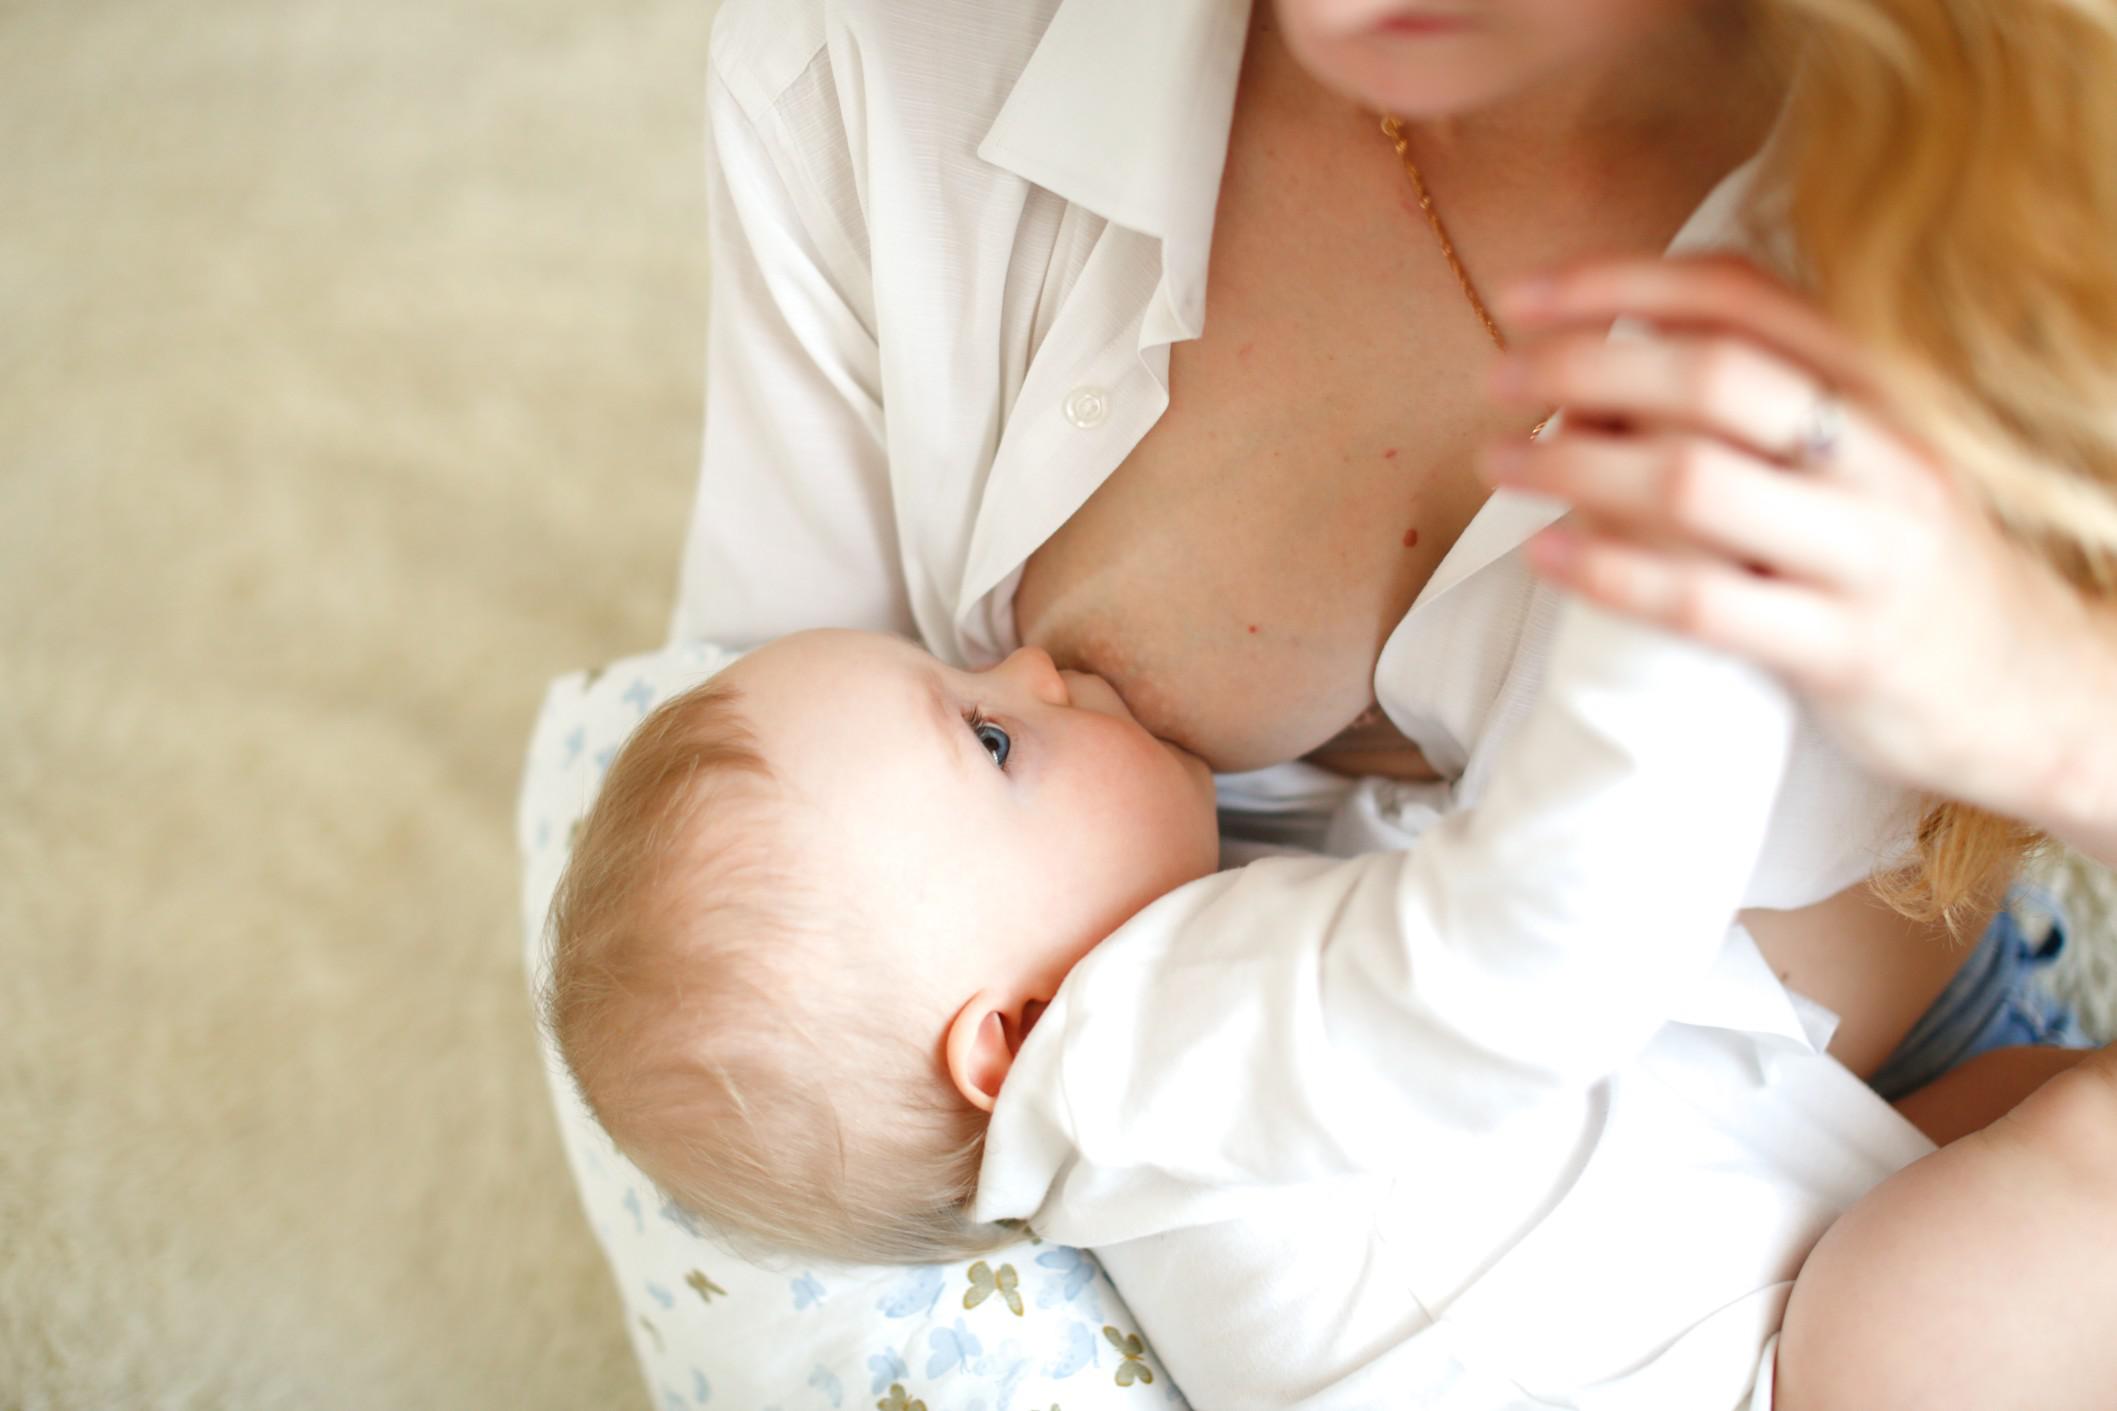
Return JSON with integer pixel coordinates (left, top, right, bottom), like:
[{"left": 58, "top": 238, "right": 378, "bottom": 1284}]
[{"left": 673, "top": 62, "right": 912, "bottom": 647}]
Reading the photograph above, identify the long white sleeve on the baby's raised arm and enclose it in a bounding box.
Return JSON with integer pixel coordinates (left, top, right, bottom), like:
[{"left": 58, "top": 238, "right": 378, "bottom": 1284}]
[{"left": 978, "top": 603, "right": 1793, "bottom": 1242}]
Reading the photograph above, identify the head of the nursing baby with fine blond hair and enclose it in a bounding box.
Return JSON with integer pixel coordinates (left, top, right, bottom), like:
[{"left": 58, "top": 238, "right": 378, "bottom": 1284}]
[{"left": 546, "top": 633, "right": 1217, "bottom": 1263}]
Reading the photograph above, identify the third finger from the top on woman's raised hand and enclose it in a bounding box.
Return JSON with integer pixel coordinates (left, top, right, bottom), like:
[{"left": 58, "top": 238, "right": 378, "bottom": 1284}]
[{"left": 1486, "top": 429, "right": 1876, "bottom": 592}]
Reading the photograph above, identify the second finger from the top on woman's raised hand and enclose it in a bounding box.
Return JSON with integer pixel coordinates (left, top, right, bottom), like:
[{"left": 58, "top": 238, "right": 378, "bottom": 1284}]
[{"left": 1492, "top": 330, "right": 1899, "bottom": 495}]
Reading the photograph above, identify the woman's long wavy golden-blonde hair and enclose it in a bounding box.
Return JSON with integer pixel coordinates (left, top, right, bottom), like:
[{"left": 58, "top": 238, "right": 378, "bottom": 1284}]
[{"left": 1759, "top": 0, "right": 2117, "bottom": 920}]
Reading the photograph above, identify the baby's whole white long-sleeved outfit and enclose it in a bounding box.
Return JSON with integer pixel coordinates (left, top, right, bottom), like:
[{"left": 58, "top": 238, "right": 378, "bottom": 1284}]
[{"left": 976, "top": 603, "right": 1931, "bottom": 1411}]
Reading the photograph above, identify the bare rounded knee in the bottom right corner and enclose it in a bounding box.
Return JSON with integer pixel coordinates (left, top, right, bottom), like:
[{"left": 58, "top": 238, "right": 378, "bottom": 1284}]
[{"left": 1774, "top": 1049, "right": 2117, "bottom": 1411}]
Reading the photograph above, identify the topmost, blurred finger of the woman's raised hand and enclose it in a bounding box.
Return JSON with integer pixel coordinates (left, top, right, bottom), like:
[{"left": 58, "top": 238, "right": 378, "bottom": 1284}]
[{"left": 1497, "top": 254, "right": 1874, "bottom": 396}]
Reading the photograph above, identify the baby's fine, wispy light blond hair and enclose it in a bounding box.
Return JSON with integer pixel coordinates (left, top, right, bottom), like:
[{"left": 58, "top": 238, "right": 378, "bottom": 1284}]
[{"left": 542, "top": 679, "right": 1012, "bottom": 1263}]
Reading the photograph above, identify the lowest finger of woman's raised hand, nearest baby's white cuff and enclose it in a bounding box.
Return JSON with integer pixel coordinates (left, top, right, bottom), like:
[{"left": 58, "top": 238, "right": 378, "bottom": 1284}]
[{"left": 1528, "top": 520, "right": 1854, "bottom": 688}]
